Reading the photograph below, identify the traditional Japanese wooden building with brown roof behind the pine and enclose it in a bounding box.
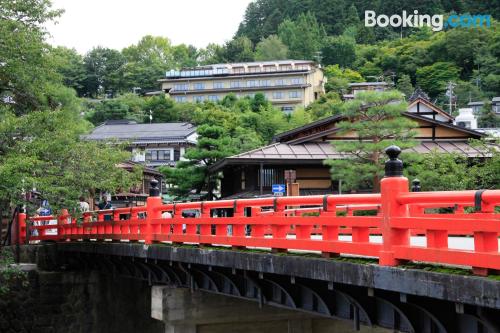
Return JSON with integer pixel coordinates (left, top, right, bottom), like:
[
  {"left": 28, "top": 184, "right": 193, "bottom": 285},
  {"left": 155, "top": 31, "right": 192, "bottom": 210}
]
[{"left": 210, "top": 91, "right": 485, "bottom": 198}]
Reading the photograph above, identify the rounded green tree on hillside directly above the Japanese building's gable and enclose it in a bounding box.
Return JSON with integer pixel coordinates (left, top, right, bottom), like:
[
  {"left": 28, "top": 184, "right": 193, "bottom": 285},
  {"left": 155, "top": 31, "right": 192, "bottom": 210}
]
[{"left": 417, "top": 62, "right": 460, "bottom": 98}]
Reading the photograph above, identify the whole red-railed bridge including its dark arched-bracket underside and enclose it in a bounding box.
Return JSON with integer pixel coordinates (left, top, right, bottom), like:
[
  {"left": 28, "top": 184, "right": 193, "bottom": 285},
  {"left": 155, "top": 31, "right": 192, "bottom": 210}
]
[{"left": 10, "top": 146, "right": 500, "bottom": 333}]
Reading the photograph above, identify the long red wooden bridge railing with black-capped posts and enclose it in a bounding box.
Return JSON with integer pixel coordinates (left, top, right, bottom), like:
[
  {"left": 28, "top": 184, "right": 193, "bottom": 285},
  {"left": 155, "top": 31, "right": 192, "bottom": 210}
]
[{"left": 20, "top": 147, "right": 500, "bottom": 275}]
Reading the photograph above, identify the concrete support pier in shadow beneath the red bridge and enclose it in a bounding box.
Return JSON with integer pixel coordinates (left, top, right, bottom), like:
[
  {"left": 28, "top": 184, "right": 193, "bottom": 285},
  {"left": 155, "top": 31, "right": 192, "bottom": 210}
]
[{"left": 151, "top": 286, "right": 390, "bottom": 333}]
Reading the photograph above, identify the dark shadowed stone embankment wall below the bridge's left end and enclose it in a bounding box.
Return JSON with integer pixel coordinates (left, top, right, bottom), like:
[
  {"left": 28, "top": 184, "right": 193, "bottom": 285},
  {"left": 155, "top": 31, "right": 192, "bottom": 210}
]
[{"left": 0, "top": 248, "right": 164, "bottom": 333}]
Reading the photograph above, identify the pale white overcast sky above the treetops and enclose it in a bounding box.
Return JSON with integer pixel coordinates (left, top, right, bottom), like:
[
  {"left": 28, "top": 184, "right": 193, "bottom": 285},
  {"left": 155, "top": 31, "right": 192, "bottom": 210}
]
[{"left": 47, "top": 0, "right": 251, "bottom": 54}]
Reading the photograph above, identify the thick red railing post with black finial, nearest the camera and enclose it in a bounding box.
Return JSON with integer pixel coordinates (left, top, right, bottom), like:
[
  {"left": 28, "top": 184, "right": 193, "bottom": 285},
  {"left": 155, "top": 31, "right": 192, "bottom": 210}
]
[{"left": 379, "top": 146, "right": 410, "bottom": 266}]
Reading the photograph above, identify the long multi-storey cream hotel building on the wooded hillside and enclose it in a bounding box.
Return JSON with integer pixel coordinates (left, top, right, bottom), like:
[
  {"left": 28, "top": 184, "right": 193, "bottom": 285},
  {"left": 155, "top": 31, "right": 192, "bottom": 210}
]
[{"left": 159, "top": 60, "right": 326, "bottom": 112}]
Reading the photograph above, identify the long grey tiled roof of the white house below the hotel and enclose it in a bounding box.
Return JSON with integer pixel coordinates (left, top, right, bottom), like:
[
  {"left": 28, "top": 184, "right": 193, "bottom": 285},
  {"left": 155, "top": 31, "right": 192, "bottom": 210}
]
[{"left": 83, "top": 123, "right": 196, "bottom": 142}]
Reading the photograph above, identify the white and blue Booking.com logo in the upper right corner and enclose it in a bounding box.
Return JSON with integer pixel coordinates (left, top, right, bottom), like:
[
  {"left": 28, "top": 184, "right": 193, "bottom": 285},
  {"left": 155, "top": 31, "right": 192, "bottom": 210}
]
[{"left": 365, "top": 10, "right": 491, "bottom": 31}]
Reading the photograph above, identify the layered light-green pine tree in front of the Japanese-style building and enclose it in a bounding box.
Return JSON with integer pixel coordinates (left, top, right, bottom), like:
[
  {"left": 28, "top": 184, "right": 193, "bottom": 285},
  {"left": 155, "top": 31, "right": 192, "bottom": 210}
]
[{"left": 325, "top": 91, "right": 416, "bottom": 192}]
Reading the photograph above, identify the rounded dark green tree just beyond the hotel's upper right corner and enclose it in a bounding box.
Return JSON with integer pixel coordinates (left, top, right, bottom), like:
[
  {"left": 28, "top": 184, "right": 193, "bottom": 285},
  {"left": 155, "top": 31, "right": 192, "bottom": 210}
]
[{"left": 321, "top": 36, "right": 356, "bottom": 67}]
